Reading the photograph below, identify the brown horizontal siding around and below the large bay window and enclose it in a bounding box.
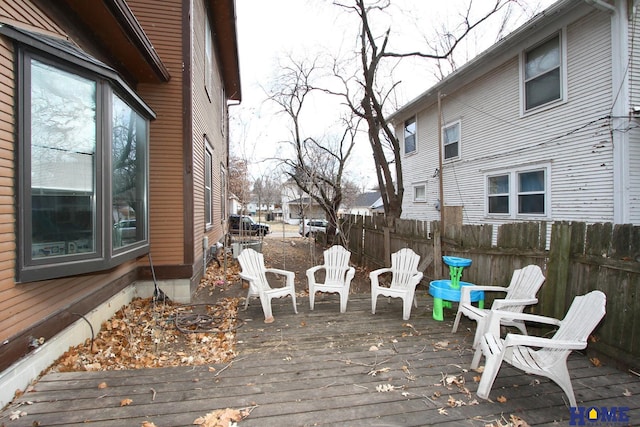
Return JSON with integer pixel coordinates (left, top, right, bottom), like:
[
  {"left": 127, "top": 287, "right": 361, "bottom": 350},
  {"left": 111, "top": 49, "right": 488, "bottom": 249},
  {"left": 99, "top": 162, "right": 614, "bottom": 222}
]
[{"left": 0, "top": 0, "right": 136, "bottom": 371}]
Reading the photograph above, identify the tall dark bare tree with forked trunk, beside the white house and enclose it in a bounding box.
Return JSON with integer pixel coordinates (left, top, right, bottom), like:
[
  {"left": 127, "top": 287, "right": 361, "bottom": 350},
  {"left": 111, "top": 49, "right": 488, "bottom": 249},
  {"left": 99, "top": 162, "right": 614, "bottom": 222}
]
[{"left": 331, "top": 0, "right": 516, "bottom": 221}]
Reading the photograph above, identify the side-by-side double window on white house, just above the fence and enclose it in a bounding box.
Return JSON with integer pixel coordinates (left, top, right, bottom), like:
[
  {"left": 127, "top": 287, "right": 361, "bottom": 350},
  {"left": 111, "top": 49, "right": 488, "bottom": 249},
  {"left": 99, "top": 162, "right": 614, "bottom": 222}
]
[{"left": 486, "top": 166, "right": 549, "bottom": 217}]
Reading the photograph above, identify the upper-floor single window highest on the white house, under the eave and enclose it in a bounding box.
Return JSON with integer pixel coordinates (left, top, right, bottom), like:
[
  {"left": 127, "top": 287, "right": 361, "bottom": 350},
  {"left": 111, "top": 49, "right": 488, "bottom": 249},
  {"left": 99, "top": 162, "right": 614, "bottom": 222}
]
[{"left": 523, "top": 33, "right": 564, "bottom": 112}]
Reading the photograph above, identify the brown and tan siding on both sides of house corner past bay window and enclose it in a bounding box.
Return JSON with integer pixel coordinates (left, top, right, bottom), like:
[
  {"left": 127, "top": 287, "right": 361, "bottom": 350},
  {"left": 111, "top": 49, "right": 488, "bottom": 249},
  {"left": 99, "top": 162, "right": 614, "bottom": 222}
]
[{"left": 128, "top": 0, "right": 227, "bottom": 276}]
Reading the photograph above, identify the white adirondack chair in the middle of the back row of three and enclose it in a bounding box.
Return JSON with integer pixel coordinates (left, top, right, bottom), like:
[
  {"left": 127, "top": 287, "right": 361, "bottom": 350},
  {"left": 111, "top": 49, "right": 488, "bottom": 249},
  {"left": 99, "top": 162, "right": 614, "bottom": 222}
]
[{"left": 307, "top": 245, "right": 356, "bottom": 313}]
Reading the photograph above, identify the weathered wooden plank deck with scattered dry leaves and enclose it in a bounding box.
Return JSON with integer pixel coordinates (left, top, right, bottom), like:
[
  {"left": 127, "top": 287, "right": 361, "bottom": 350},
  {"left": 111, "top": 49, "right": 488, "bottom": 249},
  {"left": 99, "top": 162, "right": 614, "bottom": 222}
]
[{"left": 0, "top": 292, "right": 640, "bottom": 427}]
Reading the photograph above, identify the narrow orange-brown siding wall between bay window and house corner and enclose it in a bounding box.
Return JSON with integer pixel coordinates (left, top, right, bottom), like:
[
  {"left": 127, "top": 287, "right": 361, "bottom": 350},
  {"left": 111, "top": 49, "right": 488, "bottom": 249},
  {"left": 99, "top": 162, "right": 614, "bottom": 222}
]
[{"left": 127, "top": 0, "right": 190, "bottom": 271}]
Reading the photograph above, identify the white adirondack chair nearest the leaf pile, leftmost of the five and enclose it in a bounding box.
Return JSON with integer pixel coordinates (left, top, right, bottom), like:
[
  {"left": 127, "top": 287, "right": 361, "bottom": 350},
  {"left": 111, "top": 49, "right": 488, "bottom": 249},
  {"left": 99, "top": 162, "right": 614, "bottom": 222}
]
[{"left": 238, "top": 248, "right": 298, "bottom": 323}]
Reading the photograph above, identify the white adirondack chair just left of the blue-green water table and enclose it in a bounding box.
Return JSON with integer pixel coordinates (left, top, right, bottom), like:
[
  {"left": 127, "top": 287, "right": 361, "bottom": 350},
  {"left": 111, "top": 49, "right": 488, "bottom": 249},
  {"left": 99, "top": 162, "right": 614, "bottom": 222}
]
[{"left": 369, "top": 248, "right": 422, "bottom": 320}]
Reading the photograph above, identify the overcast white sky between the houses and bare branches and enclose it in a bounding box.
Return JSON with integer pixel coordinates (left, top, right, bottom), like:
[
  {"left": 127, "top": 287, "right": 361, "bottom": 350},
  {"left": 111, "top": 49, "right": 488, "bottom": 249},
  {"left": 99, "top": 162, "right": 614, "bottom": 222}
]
[{"left": 230, "top": 0, "right": 554, "bottom": 191}]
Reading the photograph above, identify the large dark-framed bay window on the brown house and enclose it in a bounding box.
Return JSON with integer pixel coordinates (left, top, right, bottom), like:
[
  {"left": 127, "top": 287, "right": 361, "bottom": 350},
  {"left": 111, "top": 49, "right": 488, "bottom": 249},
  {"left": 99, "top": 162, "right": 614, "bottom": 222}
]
[{"left": 5, "top": 26, "right": 154, "bottom": 282}]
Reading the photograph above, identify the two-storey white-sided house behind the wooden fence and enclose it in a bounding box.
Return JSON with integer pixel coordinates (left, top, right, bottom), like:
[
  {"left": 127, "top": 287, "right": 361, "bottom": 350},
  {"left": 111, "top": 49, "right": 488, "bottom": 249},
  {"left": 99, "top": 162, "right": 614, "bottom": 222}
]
[{"left": 389, "top": 0, "right": 640, "bottom": 234}]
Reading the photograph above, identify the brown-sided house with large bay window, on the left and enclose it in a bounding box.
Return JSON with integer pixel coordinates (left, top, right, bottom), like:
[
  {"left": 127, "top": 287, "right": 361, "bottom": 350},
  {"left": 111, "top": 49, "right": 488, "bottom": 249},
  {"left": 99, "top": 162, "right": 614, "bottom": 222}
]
[{"left": 0, "top": 0, "right": 240, "bottom": 406}]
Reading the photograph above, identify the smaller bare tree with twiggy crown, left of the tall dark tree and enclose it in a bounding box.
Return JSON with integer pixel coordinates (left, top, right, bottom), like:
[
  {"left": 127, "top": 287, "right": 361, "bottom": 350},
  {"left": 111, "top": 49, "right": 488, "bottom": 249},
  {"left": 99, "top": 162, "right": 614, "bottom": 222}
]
[{"left": 269, "top": 58, "right": 359, "bottom": 244}]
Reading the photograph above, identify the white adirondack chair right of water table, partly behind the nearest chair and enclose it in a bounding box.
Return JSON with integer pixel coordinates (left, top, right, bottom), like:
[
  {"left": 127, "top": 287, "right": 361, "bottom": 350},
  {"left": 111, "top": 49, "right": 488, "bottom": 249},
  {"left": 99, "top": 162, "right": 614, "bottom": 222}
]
[{"left": 451, "top": 265, "right": 545, "bottom": 348}]
